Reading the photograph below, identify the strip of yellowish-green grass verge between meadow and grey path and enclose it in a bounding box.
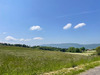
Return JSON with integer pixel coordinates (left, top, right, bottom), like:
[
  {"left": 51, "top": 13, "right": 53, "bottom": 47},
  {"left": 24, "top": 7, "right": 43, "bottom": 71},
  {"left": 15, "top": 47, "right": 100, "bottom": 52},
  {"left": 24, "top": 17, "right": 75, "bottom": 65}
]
[{"left": 43, "top": 61, "right": 100, "bottom": 75}]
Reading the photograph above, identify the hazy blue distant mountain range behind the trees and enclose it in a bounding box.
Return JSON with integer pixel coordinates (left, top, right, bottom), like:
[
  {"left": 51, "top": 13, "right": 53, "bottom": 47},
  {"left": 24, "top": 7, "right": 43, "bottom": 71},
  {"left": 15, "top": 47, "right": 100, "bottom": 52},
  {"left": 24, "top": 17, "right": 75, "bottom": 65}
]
[{"left": 41, "top": 43, "right": 100, "bottom": 49}]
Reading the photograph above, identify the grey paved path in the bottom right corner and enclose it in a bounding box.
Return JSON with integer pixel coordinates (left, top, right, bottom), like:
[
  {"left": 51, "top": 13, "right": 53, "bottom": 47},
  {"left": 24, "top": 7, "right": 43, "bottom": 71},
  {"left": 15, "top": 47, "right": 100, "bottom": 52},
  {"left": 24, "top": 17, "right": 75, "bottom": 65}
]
[{"left": 80, "top": 66, "right": 100, "bottom": 75}]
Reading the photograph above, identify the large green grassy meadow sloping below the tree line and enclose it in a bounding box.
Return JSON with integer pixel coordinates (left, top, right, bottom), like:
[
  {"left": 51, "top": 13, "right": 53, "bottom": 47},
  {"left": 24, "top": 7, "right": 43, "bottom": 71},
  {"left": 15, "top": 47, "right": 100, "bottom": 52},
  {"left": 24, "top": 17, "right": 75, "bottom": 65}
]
[{"left": 0, "top": 46, "right": 100, "bottom": 75}]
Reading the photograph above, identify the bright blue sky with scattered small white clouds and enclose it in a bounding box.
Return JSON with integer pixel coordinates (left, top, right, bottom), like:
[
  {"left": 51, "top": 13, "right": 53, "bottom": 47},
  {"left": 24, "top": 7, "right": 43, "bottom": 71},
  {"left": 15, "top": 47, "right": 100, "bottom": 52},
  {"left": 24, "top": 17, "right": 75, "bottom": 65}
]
[{"left": 0, "top": 0, "right": 100, "bottom": 45}]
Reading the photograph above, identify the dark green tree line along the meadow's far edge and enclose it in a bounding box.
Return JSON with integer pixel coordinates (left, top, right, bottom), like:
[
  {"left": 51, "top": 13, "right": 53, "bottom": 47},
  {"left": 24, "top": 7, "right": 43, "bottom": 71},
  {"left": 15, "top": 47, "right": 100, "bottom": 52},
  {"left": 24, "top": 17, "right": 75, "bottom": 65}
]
[{"left": 0, "top": 43, "right": 86, "bottom": 53}]
